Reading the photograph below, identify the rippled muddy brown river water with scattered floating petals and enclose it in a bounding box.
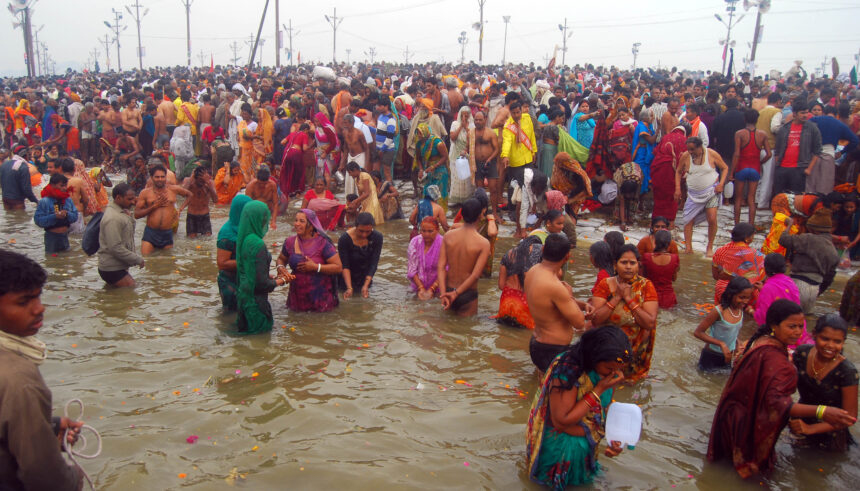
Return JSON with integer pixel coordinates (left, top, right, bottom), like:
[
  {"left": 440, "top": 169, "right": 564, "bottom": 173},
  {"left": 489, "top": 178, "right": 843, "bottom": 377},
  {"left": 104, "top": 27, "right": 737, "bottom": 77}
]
[{"left": 0, "top": 191, "right": 860, "bottom": 490}]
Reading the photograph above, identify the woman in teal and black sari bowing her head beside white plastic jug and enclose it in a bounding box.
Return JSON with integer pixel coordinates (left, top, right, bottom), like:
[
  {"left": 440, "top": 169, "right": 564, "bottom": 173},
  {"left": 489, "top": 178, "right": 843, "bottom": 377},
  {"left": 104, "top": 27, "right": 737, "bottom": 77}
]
[{"left": 526, "top": 325, "right": 630, "bottom": 490}]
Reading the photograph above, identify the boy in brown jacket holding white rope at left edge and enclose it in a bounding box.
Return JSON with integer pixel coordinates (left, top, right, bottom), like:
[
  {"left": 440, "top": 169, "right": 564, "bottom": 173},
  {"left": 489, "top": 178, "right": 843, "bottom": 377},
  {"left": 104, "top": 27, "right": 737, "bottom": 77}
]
[{"left": 0, "top": 249, "right": 83, "bottom": 490}]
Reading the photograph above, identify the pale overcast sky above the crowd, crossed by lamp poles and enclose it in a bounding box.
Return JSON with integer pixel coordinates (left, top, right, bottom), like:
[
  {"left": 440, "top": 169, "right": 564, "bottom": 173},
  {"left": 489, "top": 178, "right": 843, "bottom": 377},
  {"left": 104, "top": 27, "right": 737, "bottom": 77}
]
[{"left": 0, "top": 0, "right": 860, "bottom": 75}]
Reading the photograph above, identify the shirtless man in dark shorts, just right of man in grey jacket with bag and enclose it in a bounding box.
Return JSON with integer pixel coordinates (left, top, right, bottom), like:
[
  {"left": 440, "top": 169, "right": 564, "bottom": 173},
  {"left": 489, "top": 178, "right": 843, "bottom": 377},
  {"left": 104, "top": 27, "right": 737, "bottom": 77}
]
[{"left": 134, "top": 165, "right": 191, "bottom": 256}]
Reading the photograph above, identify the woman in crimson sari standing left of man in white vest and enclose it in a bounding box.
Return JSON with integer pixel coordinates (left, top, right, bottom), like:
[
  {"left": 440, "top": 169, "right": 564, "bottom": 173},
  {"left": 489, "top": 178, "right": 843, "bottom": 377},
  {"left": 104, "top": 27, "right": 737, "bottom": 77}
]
[{"left": 651, "top": 125, "right": 689, "bottom": 229}]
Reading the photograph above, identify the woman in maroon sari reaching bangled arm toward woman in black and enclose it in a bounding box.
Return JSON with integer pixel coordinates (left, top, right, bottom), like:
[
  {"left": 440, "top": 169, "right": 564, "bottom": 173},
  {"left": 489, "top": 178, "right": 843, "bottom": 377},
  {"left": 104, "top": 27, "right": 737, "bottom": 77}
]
[{"left": 708, "top": 299, "right": 855, "bottom": 479}]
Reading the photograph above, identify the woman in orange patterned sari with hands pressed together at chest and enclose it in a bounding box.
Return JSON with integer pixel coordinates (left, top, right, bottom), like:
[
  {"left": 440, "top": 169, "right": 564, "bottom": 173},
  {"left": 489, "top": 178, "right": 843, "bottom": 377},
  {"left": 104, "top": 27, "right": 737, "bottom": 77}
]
[{"left": 591, "top": 244, "right": 658, "bottom": 383}]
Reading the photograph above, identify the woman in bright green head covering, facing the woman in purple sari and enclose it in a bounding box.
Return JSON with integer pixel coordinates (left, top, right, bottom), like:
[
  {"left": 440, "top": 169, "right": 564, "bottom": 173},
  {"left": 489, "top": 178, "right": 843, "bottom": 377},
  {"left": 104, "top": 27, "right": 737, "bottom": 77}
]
[{"left": 236, "top": 201, "right": 290, "bottom": 334}]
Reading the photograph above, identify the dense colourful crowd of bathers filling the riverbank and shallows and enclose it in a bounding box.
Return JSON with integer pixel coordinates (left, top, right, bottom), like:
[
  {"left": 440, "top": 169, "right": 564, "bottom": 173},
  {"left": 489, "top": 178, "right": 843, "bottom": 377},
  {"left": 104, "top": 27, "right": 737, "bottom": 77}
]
[{"left": 0, "top": 60, "right": 860, "bottom": 488}]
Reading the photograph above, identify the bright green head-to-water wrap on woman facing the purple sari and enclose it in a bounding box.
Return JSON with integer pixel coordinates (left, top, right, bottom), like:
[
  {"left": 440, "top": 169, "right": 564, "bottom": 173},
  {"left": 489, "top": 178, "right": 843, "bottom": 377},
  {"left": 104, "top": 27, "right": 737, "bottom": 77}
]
[{"left": 236, "top": 201, "right": 272, "bottom": 333}]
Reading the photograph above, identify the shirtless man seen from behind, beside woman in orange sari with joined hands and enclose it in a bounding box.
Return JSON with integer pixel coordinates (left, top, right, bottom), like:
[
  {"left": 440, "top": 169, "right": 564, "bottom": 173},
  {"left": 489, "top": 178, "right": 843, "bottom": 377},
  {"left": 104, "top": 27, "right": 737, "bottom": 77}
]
[{"left": 523, "top": 234, "right": 585, "bottom": 377}]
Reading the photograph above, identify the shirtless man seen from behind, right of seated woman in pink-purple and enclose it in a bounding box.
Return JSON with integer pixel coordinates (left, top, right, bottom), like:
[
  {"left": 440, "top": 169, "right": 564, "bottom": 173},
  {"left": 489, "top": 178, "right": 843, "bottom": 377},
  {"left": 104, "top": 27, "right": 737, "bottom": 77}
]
[{"left": 437, "top": 198, "right": 490, "bottom": 317}]
